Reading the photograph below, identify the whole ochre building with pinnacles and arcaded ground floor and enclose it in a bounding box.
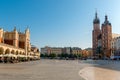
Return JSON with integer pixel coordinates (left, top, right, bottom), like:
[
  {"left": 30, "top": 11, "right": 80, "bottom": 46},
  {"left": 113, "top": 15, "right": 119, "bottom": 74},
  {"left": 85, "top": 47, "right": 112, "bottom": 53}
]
[{"left": 0, "top": 27, "right": 40, "bottom": 59}]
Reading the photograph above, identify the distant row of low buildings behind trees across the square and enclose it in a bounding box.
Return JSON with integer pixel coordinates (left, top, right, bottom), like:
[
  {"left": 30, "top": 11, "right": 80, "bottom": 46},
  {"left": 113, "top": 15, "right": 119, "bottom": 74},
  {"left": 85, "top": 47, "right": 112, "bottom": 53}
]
[{"left": 41, "top": 46, "right": 93, "bottom": 58}]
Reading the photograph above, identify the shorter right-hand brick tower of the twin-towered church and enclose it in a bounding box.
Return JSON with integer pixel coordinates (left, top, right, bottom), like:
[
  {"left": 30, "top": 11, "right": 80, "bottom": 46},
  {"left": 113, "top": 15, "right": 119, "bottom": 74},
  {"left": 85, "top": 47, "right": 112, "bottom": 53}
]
[{"left": 102, "top": 15, "right": 112, "bottom": 57}]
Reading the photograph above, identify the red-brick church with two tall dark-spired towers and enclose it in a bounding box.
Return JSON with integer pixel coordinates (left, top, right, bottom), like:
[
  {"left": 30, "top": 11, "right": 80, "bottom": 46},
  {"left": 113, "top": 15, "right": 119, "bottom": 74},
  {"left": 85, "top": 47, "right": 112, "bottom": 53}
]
[{"left": 92, "top": 13, "right": 112, "bottom": 58}]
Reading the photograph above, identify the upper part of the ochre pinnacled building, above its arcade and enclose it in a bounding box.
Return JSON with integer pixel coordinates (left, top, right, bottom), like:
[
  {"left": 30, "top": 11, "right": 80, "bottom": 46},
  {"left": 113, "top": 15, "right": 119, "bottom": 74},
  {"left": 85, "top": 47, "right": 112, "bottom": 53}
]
[{"left": 0, "top": 28, "right": 31, "bottom": 51}]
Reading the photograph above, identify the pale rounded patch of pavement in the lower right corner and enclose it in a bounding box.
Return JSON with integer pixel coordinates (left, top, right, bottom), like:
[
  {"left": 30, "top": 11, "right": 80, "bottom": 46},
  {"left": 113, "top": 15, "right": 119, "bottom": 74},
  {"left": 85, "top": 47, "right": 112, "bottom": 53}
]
[{"left": 79, "top": 67, "right": 120, "bottom": 80}]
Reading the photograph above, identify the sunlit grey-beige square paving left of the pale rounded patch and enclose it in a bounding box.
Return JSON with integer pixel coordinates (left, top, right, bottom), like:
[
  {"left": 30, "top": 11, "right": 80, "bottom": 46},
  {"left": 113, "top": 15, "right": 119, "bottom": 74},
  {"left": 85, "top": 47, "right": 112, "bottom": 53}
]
[{"left": 0, "top": 59, "right": 92, "bottom": 80}]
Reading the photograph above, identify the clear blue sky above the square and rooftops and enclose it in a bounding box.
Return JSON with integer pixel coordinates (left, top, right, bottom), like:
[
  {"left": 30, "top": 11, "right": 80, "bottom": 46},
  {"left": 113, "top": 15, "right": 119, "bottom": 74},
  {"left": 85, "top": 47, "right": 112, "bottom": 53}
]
[{"left": 0, "top": 0, "right": 120, "bottom": 49}]
